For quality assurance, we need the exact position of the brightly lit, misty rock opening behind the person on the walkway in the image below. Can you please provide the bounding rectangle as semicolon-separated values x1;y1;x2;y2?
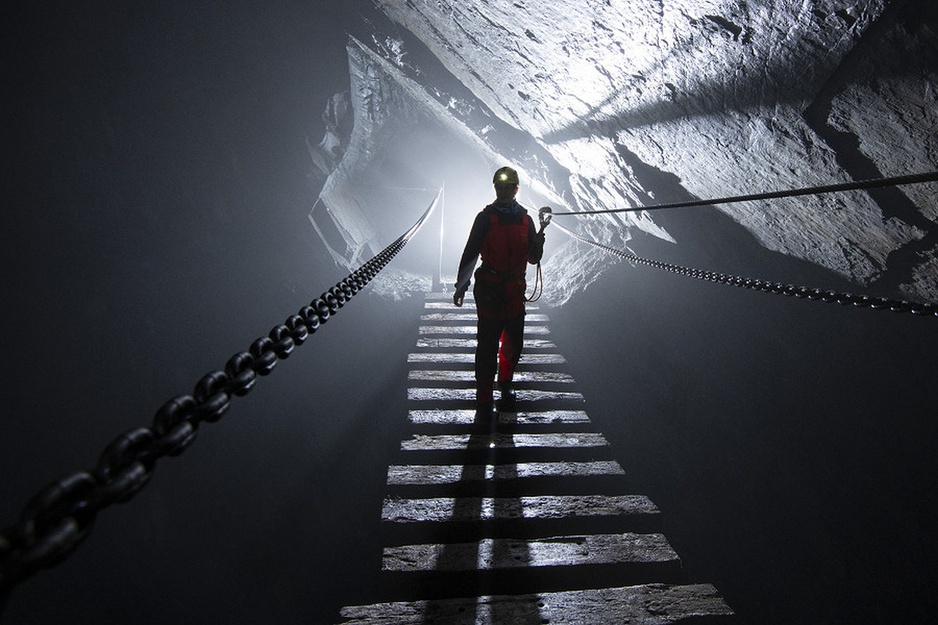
309;35;565;290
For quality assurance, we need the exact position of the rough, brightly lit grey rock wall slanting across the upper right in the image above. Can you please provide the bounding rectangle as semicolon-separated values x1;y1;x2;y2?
362;0;938;303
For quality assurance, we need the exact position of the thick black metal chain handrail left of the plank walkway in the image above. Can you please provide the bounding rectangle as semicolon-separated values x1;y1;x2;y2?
0;193;440;596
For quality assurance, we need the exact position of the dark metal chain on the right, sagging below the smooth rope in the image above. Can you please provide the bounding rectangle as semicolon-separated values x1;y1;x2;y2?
555;222;938;317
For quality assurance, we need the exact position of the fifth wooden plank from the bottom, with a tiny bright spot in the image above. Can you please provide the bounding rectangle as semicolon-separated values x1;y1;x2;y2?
401;432;609;451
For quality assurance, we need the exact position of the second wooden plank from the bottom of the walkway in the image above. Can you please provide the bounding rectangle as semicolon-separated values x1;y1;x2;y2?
381;532;681;572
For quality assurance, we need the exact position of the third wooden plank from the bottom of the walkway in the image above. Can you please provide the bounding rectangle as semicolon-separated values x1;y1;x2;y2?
381;495;659;523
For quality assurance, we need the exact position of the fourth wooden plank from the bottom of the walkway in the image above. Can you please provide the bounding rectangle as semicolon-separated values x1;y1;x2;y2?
387;460;625;486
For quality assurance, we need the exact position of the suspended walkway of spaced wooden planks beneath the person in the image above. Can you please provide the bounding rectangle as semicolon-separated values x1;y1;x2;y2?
341;293;733;625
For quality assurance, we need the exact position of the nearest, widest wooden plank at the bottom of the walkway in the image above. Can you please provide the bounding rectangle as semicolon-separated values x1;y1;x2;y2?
340;584;733;625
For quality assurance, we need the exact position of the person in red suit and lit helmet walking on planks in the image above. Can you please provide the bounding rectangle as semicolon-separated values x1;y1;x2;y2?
453;167;544;410
